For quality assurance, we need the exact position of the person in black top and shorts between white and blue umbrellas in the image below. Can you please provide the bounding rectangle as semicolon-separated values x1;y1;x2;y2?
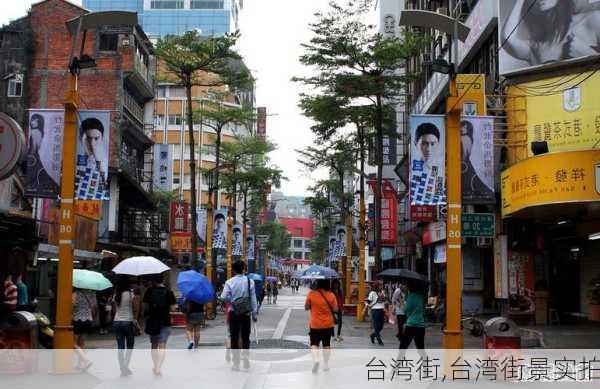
142;274;177;377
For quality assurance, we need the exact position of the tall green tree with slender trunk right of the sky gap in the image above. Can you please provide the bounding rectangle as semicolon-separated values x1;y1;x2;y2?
294;0;427;269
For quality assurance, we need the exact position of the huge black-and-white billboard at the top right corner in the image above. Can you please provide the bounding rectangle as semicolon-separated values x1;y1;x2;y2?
498;0;600;74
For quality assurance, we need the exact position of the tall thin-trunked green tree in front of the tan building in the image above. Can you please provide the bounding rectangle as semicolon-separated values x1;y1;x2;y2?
155;30;252;266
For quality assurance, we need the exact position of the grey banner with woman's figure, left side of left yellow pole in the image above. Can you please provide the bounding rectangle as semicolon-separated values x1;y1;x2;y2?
25;109;65;199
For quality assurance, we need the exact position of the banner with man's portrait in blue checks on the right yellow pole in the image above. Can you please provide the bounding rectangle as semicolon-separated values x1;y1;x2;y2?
410;115;446;205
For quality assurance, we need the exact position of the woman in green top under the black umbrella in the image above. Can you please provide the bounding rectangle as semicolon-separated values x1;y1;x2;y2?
399;284;427;358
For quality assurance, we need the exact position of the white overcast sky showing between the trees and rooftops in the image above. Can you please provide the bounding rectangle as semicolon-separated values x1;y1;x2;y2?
0;0;376;196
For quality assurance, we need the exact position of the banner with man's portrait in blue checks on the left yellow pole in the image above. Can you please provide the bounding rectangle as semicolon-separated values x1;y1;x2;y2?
75;110;110;200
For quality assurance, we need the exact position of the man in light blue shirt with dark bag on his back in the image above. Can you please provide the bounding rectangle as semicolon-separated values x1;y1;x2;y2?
221;261;257;371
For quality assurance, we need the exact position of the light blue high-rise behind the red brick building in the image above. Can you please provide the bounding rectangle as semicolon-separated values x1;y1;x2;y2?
83;0;244;39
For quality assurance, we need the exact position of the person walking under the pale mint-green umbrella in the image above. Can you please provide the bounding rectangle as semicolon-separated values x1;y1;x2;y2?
72;289;98;371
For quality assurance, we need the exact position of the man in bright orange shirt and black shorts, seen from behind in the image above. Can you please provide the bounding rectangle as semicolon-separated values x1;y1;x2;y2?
304;280;338;374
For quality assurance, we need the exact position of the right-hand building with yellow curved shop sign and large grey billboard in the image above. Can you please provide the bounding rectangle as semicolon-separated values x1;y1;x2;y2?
401;0;600;324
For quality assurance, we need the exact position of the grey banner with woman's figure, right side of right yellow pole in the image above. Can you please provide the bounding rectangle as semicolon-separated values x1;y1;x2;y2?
460;116;496;204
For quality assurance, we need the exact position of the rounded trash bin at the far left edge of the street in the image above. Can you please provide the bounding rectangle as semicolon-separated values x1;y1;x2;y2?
0;311;38;374
